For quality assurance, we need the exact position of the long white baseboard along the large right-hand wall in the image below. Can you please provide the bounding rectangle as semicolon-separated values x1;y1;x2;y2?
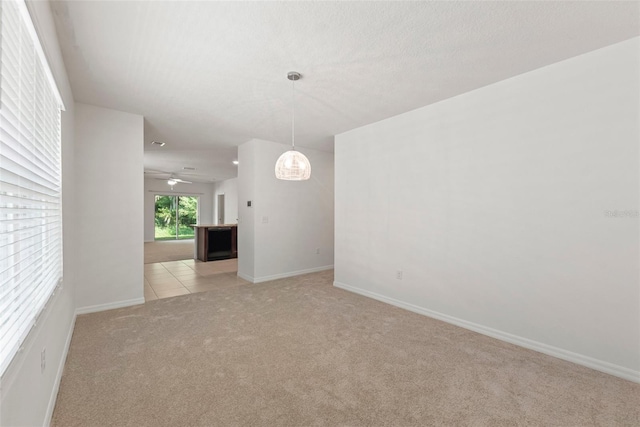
333;281;640;383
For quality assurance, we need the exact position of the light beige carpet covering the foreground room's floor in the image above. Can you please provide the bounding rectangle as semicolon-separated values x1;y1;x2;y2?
53;272;640;426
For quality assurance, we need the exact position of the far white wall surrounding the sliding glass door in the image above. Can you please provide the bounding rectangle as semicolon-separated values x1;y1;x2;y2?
144;178;215;242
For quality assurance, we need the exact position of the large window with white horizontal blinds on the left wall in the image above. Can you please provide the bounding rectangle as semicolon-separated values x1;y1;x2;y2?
0;0;62;374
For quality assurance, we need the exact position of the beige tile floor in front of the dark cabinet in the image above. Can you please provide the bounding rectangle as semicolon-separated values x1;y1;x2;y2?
144;258;250;301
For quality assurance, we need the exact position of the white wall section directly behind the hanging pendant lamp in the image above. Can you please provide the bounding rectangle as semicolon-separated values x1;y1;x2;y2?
238;140;334;283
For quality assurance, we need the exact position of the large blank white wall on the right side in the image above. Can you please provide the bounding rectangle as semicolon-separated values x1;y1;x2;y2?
335;38;640;381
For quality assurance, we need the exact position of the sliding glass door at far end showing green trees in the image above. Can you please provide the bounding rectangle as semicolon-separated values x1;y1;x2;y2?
154;194;198;240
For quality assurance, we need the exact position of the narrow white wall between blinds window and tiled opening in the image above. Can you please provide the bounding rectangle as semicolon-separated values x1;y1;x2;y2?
74;103;144;312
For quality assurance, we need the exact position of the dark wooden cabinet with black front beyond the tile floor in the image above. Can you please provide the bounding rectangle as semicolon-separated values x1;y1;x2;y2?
193;224;238;262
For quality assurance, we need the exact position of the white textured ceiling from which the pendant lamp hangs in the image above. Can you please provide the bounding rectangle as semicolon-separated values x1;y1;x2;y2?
52;1;640;181
